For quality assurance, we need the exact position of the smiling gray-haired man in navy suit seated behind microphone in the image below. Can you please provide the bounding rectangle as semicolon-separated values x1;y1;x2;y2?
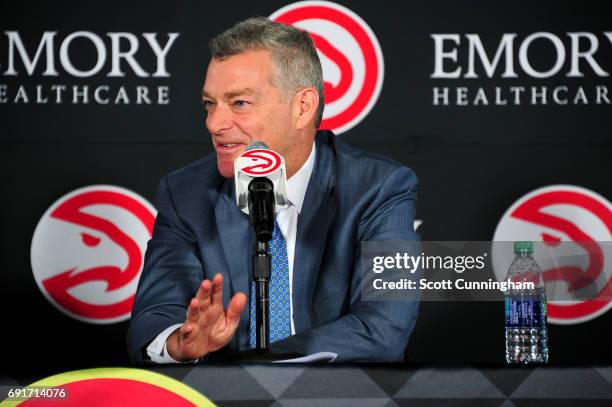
128;18;418;363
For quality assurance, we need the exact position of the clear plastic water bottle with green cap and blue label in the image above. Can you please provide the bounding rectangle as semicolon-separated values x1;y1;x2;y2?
505;242;548;364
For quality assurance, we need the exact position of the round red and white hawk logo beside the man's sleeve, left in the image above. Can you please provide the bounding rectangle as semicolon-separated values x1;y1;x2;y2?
31;185;157;324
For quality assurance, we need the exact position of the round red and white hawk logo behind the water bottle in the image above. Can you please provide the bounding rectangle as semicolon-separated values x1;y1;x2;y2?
493;185;612;324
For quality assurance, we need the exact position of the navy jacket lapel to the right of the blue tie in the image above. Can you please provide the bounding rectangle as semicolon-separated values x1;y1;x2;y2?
292;132;336;333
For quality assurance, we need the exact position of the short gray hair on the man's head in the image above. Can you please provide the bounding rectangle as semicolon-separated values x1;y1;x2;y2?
209;17;324;128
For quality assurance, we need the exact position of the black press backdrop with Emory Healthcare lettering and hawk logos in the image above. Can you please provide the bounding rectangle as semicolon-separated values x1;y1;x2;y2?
0;0;612;372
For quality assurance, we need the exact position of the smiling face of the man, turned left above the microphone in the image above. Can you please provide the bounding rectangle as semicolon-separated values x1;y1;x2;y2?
202;51;295;178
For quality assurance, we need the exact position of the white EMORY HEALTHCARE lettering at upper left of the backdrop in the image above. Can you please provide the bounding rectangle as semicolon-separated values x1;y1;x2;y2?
0;31;180;106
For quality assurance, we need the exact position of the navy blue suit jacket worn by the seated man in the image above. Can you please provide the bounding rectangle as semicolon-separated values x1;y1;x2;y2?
128;131;419;363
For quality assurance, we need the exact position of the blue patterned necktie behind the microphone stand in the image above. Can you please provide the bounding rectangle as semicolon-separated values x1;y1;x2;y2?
250;222;291;348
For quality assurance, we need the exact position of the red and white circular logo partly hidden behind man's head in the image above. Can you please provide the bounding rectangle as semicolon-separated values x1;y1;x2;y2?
270;1;384;134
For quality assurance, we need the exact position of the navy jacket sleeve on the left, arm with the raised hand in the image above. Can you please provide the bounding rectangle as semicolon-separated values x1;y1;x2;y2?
127;179;203;364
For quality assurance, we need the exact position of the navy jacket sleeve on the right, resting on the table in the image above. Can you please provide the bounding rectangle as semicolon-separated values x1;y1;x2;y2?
271;167;420;362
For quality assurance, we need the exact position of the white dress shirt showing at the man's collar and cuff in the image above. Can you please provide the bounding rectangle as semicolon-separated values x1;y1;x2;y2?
147;143;316;363
